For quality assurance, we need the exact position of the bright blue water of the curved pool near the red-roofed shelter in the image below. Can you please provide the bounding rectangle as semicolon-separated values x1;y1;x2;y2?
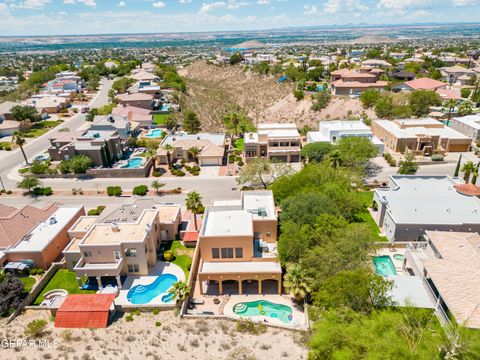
127;274;178;304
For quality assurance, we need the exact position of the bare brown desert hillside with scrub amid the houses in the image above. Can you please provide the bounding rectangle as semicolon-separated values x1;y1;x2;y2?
180;61;374;131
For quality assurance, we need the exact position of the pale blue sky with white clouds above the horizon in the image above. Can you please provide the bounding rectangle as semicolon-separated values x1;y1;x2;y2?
0;0;480;35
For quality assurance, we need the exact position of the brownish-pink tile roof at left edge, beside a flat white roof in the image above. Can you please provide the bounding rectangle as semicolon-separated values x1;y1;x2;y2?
0;203;59;249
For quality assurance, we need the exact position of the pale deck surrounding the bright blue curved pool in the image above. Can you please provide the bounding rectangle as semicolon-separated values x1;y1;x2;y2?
115;261;185;307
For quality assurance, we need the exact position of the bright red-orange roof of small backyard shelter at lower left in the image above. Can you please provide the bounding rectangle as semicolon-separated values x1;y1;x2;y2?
55;294;115;329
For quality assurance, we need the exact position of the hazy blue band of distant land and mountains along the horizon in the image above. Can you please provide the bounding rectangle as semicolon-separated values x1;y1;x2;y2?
0;23;480;52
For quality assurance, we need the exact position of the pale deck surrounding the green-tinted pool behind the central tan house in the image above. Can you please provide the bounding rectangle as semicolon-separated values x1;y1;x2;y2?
223;295;306;329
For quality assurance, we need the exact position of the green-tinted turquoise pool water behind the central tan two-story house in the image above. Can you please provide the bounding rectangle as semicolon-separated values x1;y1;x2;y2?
233;300;293;324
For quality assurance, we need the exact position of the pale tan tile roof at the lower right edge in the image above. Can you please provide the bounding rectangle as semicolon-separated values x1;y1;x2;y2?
422;231;480;328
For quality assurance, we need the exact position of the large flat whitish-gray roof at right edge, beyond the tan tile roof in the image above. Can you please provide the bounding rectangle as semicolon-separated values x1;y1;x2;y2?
375;175;480;225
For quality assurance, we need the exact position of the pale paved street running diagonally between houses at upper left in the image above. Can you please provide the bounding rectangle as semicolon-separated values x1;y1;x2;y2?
0;80;113;188
